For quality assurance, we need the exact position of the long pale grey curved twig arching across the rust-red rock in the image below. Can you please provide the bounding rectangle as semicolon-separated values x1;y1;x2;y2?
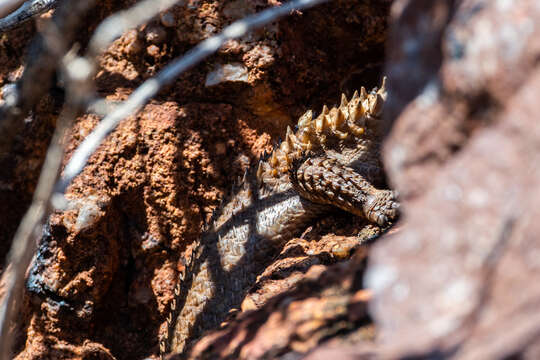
59;0;328;194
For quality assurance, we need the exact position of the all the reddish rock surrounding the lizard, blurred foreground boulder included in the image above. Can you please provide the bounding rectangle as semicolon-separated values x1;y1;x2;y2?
0;0;540;360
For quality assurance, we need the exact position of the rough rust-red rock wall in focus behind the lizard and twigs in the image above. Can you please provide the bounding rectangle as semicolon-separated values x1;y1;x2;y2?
0;0;390;359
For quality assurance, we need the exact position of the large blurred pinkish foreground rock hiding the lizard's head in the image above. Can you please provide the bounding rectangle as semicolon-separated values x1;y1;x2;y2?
366;0;540;359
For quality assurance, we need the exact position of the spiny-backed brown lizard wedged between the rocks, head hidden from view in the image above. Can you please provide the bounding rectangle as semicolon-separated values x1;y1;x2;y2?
159;78;399;358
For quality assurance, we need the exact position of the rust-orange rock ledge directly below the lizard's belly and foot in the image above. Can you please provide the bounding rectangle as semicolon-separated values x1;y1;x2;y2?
177;236;374;359
